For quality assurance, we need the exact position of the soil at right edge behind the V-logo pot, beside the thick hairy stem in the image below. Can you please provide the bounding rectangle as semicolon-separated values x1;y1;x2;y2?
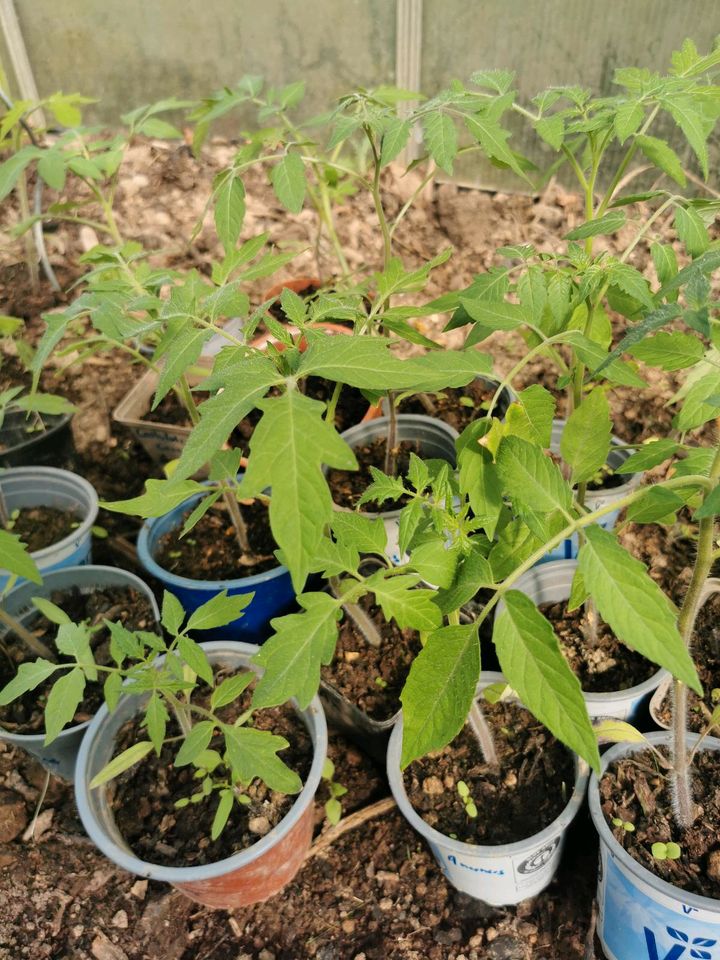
659;593;720;736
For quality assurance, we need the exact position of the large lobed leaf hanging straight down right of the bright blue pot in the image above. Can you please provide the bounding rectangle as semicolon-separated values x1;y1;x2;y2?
241;388;357;590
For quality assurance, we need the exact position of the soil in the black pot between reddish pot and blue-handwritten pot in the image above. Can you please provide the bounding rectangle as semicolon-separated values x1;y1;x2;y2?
322;597;422;721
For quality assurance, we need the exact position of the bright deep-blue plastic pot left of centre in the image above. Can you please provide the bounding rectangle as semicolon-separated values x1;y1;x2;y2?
137;494;295;643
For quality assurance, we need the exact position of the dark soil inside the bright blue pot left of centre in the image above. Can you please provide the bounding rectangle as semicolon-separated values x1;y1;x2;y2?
155;500;278;580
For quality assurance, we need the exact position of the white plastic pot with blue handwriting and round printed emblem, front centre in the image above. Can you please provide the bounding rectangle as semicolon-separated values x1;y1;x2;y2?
387;672;588;907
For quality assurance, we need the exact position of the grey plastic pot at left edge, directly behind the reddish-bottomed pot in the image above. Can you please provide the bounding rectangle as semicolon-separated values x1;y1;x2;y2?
0;565;160;780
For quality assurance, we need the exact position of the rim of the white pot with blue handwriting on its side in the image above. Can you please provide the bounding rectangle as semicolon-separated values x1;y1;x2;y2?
387;670;588;859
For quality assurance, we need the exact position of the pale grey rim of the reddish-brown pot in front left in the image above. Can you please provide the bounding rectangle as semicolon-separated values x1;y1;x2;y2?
75;640;327;885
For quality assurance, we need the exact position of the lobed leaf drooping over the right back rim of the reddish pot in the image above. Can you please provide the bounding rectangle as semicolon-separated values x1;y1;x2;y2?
253;593;340;710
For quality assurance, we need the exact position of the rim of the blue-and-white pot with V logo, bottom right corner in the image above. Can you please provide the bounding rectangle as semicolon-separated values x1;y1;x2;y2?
588;730;720;913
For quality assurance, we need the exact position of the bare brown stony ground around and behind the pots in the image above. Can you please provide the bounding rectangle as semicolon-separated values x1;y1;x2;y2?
0;131;716;960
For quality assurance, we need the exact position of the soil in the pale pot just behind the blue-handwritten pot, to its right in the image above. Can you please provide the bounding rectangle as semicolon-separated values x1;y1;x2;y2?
538;600;658;693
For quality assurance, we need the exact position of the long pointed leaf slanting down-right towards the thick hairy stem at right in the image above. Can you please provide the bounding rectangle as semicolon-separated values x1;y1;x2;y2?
578;526;702;693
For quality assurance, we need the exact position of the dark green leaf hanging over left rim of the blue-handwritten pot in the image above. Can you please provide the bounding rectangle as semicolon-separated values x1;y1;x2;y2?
400;624;480;769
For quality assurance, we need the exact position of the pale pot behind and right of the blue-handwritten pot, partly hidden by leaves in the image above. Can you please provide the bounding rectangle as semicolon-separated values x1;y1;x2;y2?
504;560;668;722
